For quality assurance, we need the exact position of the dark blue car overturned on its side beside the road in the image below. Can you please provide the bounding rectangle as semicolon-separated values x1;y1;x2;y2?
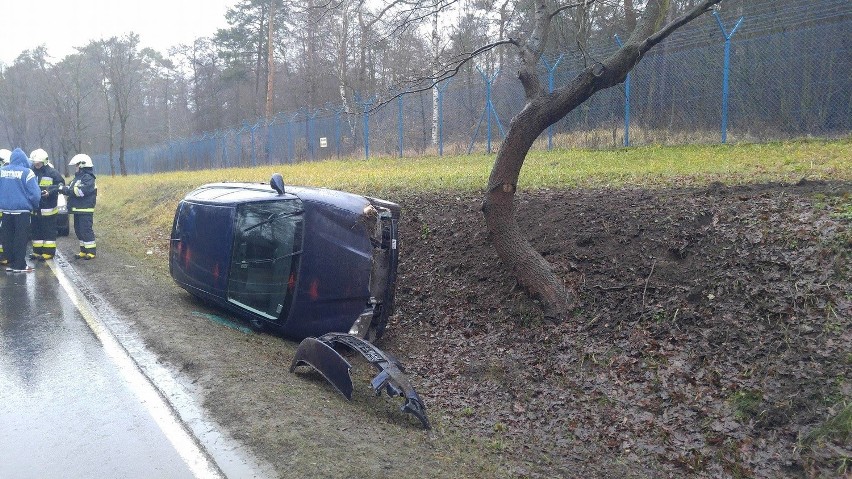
169;174;400;340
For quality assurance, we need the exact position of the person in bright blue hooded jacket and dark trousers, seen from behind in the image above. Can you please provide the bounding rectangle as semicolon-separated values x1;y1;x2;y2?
0;148;41;273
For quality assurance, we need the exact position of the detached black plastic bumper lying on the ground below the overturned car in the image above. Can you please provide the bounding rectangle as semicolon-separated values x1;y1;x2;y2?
290;333;429;429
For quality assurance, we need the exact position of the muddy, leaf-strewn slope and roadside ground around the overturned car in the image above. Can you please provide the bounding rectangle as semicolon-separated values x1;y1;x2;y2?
58;182;852;478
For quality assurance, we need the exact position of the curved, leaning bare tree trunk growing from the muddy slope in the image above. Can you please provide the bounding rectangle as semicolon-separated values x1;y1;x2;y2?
482;0;721;321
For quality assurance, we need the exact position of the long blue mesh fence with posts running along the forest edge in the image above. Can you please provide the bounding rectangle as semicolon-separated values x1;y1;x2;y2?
95;0;852;173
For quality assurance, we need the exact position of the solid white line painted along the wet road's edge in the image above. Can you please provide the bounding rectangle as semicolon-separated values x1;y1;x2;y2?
46;261;225;479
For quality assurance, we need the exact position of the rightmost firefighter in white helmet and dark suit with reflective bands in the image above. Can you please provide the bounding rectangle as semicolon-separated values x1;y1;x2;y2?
59;153;98;259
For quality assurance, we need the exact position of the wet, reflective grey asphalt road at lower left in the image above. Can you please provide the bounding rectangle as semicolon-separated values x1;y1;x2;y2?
0;263;223;479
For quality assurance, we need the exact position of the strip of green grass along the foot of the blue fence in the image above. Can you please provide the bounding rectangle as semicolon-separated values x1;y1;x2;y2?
95;138;852;270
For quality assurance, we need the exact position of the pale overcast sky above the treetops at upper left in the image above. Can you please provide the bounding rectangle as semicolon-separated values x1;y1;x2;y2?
0;0;238;65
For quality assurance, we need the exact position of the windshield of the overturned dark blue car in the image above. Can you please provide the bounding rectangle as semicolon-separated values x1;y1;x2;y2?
228;199;303;319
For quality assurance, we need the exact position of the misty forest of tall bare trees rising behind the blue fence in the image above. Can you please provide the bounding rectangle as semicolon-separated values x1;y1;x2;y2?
0;0;850;176
